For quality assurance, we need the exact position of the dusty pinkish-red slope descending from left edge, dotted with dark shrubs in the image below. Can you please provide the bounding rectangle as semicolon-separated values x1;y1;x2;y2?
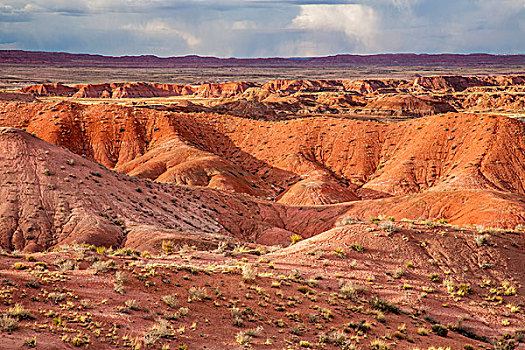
0;128;350;251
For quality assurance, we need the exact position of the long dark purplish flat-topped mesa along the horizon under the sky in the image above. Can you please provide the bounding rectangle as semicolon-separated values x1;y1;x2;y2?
0;50;525;67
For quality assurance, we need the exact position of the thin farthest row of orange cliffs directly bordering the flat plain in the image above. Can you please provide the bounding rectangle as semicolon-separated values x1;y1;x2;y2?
20;76;525;101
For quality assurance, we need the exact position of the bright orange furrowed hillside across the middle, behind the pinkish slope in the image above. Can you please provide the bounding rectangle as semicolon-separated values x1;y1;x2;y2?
0;103;525;227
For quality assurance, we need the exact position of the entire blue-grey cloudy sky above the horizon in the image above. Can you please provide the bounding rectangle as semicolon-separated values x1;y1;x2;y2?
0;0;525;57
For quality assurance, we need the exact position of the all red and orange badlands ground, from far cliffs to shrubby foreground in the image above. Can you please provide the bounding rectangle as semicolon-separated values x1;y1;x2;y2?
0;77;525;349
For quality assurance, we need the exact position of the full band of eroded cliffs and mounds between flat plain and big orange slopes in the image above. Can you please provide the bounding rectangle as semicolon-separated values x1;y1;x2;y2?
21;76;525;120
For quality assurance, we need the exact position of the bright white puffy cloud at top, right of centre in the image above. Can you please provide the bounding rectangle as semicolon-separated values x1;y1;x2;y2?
291;4;377;47
